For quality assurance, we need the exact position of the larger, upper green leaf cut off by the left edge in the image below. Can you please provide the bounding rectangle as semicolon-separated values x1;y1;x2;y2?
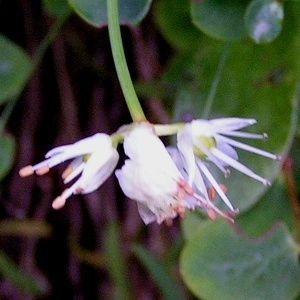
0;34;31;105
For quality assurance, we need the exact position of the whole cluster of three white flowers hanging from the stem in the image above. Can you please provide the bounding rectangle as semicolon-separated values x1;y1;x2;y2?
20;118;279;224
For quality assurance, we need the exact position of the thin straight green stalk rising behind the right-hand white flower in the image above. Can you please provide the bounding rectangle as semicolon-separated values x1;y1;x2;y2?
202;42;231;119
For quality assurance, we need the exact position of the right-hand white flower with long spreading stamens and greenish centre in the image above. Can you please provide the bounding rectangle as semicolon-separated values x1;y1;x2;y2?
177;118;279;210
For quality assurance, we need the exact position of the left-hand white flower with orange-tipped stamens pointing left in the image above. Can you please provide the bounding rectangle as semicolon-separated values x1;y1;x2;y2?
19;133;119;209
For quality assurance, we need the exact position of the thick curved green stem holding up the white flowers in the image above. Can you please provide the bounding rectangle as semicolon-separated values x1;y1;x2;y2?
107;0;147;122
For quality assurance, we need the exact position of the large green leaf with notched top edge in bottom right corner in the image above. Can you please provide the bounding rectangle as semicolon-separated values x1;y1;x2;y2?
180;220;300;300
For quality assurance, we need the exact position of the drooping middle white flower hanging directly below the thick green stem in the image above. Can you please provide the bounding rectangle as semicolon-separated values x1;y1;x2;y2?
116;125;230;224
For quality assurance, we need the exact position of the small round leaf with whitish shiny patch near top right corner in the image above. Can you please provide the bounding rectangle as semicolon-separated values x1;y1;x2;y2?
245;0;283;43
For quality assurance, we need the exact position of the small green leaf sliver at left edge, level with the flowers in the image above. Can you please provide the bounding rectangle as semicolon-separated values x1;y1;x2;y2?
0;135;16;180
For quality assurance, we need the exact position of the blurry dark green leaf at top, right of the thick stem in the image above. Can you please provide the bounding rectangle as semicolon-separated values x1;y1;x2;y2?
154;0;202;51
